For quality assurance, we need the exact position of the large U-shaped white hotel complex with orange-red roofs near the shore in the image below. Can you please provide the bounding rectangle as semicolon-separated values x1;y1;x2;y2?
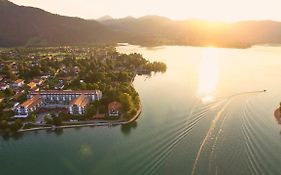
16;90;102;117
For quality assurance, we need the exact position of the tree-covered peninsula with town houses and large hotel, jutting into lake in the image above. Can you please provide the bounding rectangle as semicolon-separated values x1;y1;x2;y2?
0;45;167;133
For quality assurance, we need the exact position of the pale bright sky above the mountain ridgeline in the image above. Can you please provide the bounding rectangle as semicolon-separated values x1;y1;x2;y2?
11;0;281;22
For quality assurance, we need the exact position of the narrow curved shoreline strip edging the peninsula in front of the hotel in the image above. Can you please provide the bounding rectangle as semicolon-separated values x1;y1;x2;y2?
17;104;142;133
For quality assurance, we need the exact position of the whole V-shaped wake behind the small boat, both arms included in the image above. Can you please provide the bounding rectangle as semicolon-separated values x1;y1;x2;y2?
120;91;264;175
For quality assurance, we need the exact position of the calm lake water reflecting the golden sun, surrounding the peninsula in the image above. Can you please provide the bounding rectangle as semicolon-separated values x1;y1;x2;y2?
0;45;281;175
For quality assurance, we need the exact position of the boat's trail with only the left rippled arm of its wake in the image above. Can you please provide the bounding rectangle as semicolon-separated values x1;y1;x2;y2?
127;91;263;175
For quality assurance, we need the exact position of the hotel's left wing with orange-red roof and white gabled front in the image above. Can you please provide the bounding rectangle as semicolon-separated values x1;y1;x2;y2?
16;95;43;117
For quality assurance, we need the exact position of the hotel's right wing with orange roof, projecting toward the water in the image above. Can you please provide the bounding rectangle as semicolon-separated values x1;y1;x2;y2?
68;94;90;115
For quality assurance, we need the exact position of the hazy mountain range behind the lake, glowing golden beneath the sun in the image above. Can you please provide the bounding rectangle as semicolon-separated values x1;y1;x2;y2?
0;0;281;47
